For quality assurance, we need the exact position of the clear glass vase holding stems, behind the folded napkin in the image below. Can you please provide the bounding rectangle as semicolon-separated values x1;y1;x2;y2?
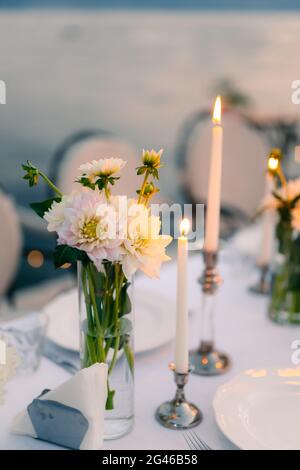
78;262;134;439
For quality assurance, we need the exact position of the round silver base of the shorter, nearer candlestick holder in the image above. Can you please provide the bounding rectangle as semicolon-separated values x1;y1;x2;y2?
155;400;203;430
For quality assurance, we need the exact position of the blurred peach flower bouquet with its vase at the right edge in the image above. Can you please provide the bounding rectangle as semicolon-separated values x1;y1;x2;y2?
263;149;300;323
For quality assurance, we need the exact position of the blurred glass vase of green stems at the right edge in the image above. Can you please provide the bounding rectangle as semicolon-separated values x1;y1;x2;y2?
268;236;300;324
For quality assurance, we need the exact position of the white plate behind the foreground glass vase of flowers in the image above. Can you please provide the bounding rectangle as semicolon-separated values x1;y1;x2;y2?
44;289;175;353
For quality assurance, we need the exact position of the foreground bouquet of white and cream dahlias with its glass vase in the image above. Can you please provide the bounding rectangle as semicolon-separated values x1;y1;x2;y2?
23;150;171;438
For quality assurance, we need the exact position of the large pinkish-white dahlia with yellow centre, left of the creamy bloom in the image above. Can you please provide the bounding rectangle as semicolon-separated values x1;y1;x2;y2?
57;188;121;269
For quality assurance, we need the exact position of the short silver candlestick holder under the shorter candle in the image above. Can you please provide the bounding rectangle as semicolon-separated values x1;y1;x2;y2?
155;363;202;430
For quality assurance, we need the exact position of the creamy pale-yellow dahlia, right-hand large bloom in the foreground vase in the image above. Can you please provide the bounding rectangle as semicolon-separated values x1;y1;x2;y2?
122;201;172;279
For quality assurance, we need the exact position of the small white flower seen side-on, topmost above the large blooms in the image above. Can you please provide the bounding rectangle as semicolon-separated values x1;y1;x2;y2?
79;158;126;183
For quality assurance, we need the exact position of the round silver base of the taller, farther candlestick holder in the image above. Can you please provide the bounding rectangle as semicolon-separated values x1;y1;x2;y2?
190;342;230;376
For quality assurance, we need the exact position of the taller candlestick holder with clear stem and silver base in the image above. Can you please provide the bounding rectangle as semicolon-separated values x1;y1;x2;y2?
190;251;230;375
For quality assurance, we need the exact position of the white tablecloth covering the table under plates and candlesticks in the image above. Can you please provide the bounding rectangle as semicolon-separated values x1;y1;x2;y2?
0;254;300;450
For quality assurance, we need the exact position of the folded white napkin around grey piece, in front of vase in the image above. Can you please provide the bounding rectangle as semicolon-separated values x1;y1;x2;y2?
11;363;108;450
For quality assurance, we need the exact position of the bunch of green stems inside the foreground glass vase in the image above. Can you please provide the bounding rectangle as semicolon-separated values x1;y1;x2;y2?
81;262;134;410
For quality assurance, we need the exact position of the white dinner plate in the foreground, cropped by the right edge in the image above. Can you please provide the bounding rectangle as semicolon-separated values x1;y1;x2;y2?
213;368;300;450
